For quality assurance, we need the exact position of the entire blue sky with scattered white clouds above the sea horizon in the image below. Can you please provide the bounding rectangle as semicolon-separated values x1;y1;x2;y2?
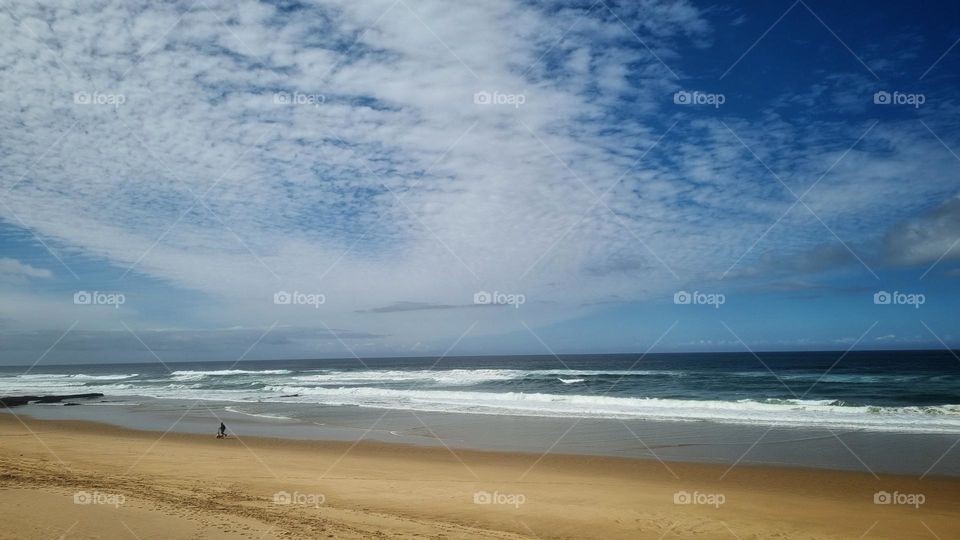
0;0;960;365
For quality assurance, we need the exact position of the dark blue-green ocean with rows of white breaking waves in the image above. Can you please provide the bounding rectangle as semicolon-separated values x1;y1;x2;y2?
0;351;960;434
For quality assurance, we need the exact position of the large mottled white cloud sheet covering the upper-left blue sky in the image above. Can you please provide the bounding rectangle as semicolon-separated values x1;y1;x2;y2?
0;0;950;358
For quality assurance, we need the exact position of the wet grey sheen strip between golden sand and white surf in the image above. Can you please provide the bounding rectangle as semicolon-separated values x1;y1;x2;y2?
7;397;960;477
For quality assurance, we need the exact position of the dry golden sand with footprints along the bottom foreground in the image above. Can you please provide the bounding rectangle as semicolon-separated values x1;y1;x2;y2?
0;415;960;539
